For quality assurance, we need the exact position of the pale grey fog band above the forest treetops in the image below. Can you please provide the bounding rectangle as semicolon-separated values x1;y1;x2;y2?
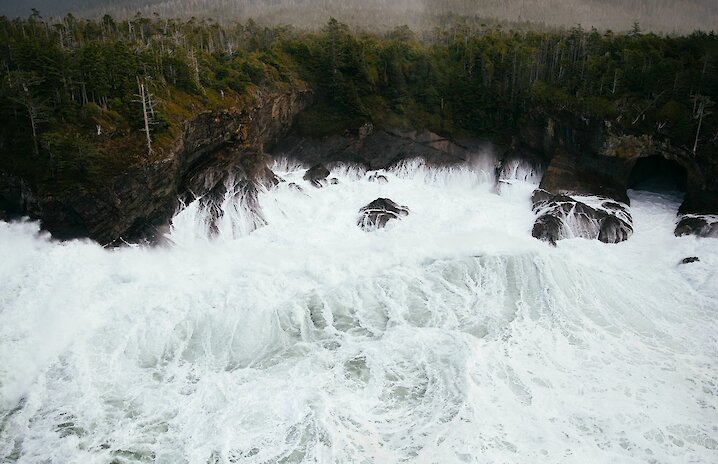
0;0;718;33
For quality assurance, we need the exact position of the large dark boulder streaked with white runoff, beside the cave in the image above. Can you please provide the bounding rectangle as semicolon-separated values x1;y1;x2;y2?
531;190;633;245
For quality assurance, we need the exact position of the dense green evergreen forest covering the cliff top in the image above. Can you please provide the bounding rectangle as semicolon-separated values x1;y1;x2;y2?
0;14;718;191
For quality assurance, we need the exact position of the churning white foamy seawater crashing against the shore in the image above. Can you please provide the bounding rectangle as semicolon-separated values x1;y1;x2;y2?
0;157;718;464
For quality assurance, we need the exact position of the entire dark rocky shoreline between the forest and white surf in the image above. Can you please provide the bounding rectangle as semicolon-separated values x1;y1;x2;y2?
0;95;718;245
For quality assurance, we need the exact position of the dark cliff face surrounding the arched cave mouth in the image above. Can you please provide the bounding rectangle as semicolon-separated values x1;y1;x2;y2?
517;111;718;237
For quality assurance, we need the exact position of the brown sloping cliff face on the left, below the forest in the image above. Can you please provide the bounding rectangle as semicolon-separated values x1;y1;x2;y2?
0;89;311;244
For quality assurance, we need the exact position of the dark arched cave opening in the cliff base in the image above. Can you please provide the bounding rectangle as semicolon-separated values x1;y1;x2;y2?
628;155;688;192
